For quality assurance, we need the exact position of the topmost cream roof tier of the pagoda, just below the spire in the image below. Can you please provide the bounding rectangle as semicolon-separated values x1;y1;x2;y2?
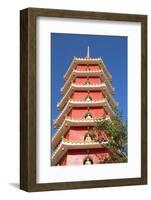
64;57;112;81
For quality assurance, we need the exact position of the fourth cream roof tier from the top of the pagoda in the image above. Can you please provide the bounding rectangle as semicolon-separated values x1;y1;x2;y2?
54;98;115;127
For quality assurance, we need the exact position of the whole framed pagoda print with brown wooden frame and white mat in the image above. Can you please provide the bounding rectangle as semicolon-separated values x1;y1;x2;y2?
20;8;147;191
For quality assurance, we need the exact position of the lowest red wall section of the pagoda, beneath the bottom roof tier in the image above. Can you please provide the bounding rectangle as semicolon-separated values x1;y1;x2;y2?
59;148;110;166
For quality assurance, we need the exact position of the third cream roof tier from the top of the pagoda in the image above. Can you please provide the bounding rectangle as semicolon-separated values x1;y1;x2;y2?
57;83;118;109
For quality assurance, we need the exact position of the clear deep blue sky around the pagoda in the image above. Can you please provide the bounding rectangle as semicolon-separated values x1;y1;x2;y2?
50;33;127;135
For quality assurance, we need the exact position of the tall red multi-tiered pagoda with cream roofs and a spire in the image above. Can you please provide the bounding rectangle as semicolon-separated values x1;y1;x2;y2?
51;47;117;166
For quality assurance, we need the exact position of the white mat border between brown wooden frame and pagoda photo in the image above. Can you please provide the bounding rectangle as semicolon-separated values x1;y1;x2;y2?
36;17;141;183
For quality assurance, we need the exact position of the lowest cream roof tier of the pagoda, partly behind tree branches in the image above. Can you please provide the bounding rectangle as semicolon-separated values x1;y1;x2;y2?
51;139;108;165
